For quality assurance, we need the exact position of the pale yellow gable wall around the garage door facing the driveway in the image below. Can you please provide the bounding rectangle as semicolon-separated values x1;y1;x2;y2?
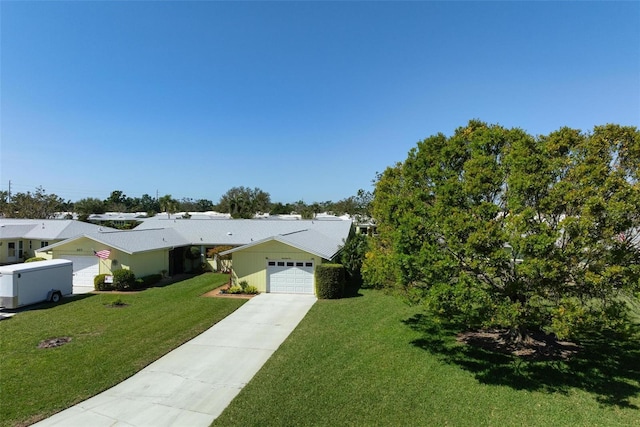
232;241;323;292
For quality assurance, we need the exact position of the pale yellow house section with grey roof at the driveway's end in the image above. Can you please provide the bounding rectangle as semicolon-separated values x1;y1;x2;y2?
137;217;352;294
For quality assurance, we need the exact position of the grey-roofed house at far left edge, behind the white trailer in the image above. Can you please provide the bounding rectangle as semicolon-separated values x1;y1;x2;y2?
0;218;112;264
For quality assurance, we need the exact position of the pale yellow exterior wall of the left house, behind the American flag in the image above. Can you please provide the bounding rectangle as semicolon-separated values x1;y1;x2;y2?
37;237;169;277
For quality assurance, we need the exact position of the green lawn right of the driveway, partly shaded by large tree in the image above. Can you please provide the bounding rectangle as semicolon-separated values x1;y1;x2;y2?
213;290;640;426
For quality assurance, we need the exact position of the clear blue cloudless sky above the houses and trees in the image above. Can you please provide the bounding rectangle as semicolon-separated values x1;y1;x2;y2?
0;1;640;203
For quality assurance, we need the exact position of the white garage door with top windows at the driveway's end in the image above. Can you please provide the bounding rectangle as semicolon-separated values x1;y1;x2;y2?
267;260;314;295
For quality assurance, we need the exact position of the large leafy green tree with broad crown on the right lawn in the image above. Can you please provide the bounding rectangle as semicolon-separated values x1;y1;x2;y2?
363;121;640;339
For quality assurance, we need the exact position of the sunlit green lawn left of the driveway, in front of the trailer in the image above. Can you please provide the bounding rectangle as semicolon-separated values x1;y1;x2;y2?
0;274;244;426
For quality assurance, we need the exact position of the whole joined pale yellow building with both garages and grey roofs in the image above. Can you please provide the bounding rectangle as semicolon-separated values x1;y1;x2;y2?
37;219;352;294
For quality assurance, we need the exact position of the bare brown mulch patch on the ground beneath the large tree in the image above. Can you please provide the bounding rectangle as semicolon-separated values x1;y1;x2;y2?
457;329;580;360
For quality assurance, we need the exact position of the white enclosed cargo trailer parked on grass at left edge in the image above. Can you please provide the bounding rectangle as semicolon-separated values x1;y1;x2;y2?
0;259;73;308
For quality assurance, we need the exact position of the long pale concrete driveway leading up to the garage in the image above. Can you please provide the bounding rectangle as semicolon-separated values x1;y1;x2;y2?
35;294;316;427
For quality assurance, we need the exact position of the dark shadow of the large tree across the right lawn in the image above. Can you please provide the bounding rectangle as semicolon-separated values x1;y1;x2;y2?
404;314;640;409
